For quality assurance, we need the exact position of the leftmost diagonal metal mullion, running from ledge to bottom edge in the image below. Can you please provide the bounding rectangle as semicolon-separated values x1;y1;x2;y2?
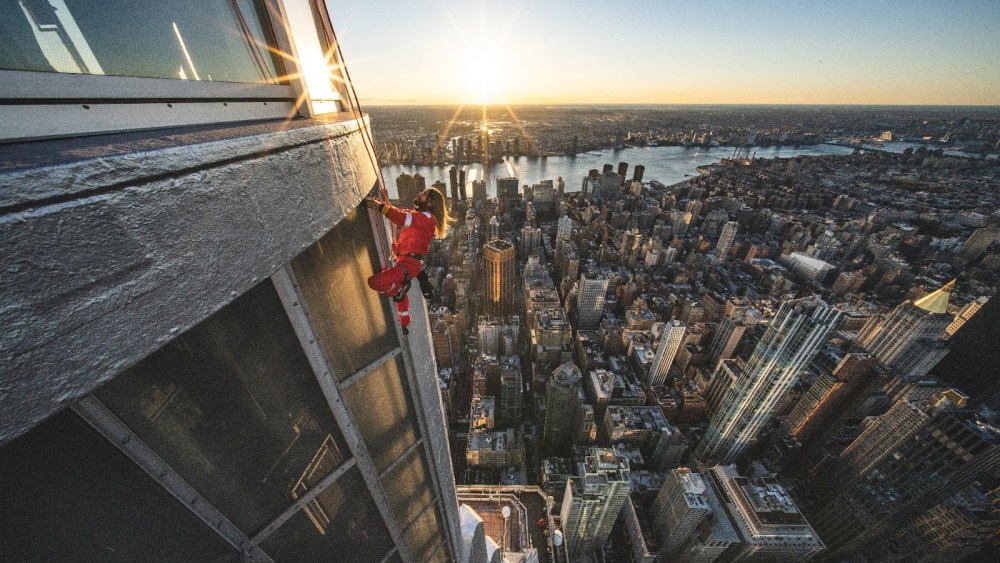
72;395;273;563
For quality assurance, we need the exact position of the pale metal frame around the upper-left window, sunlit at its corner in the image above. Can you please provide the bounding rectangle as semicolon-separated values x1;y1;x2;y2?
0;0;347;143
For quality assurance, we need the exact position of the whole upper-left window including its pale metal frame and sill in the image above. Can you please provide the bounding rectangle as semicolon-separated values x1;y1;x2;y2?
0;0;314;141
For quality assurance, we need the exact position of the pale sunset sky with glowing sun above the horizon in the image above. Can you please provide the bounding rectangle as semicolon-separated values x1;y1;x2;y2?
327;0;1000;105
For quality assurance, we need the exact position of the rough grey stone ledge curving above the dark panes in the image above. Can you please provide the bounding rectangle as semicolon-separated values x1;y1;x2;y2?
0;114;376;443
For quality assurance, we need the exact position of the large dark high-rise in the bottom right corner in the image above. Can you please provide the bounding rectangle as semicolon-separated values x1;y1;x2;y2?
813;390;1000;561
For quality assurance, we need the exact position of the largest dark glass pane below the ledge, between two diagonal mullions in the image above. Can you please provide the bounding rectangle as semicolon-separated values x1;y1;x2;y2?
97;280;349;534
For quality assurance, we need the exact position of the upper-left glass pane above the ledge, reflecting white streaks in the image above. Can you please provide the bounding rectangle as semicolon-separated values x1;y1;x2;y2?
0;0;282;84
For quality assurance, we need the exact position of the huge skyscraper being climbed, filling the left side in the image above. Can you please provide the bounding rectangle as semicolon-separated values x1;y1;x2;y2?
0;2;462;561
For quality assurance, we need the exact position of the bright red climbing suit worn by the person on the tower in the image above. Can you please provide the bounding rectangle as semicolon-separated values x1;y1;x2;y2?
368;204;437;328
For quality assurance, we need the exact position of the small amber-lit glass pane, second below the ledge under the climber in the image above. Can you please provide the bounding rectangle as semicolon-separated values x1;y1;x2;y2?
344;356;418;473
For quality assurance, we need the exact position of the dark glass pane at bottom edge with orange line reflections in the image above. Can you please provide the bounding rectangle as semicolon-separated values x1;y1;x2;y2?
261;469;394;563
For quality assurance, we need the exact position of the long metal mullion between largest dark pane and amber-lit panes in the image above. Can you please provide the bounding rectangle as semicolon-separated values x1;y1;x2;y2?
271;264;413;562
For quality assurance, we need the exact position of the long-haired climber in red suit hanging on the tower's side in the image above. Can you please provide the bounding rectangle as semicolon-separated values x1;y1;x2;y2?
365;188;450;334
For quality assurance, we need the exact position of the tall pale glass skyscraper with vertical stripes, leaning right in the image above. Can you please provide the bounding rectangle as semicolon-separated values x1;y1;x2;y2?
696;296;840;463
